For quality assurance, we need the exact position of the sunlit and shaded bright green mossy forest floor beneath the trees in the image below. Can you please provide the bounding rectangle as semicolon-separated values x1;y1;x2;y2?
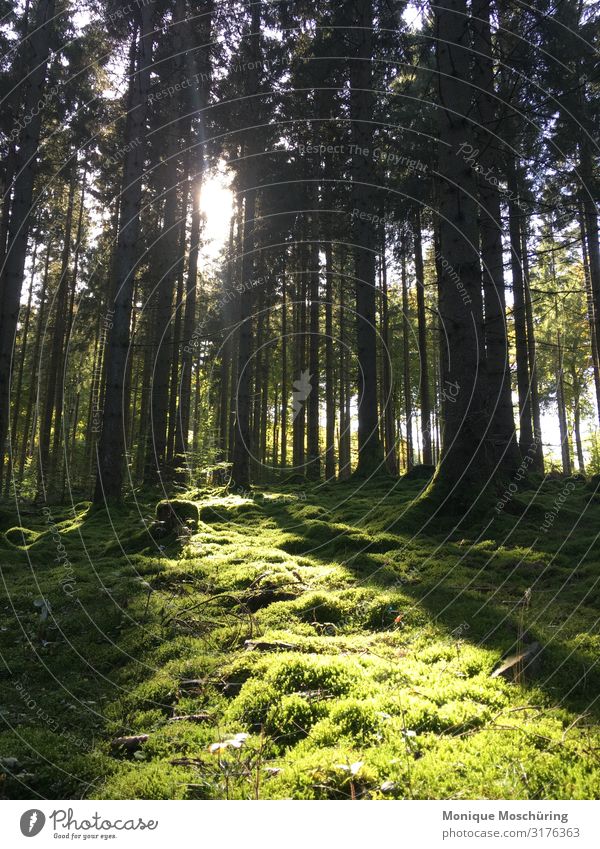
0;478;600;799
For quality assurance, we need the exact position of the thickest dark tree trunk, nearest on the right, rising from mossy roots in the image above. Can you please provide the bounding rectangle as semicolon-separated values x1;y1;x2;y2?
434;0;495;489
